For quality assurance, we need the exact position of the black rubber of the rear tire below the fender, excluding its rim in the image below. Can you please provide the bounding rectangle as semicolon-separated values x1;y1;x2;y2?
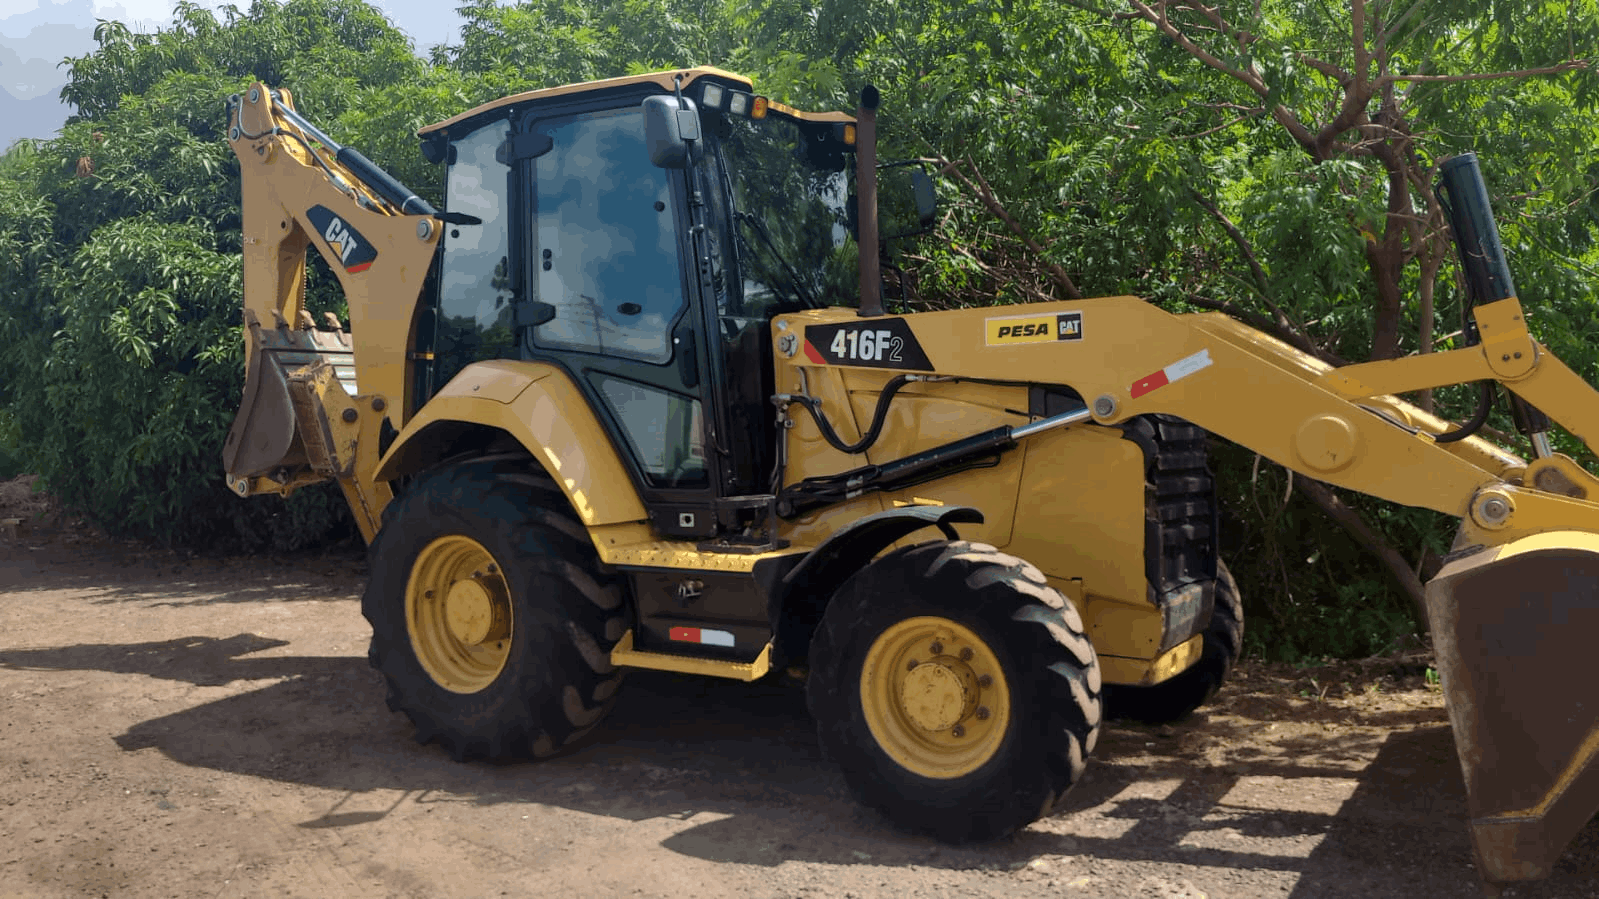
361;457;627;761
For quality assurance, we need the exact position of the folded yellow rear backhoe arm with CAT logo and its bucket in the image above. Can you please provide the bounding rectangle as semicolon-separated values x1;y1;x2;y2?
222;83;440;541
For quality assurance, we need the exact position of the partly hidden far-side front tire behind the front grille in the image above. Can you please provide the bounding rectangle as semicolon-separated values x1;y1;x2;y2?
1105;561;1244;725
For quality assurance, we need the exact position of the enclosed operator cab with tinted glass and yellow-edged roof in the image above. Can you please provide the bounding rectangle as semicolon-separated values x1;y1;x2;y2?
416;69;857;542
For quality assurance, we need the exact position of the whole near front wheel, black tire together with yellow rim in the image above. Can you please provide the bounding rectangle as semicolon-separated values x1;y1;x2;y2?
806;541;1100;841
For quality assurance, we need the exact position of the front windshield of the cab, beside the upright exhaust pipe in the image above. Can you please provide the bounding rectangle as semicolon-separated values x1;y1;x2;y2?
708;114;859;320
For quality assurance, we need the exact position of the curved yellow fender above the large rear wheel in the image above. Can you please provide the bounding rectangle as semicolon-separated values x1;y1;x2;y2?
376;360;646;528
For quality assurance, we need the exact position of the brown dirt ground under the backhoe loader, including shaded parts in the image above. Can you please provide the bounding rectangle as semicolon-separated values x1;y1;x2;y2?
0;481;1599;899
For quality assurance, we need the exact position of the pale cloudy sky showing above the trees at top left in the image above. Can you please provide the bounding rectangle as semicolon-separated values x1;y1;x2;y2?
0;0;461;150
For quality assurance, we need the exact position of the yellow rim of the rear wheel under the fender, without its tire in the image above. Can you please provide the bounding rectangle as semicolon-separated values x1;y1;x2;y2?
405;534;512;693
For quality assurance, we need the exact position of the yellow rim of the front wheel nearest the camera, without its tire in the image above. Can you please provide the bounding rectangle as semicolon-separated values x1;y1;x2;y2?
860;616;1011;779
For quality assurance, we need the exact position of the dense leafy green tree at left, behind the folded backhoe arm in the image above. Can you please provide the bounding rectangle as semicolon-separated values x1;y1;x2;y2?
0;0;461;547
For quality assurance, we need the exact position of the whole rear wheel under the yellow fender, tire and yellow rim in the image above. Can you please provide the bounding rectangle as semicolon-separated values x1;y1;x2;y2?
361;459;625;761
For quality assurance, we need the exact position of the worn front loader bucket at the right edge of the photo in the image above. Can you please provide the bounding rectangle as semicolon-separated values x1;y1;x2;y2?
1426;531;1599;883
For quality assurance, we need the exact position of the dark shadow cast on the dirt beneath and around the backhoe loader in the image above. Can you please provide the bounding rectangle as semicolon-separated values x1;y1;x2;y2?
9;633;1599;899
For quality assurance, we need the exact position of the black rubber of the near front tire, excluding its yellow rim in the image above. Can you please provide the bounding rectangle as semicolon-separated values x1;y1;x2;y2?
806;541;1100;843
